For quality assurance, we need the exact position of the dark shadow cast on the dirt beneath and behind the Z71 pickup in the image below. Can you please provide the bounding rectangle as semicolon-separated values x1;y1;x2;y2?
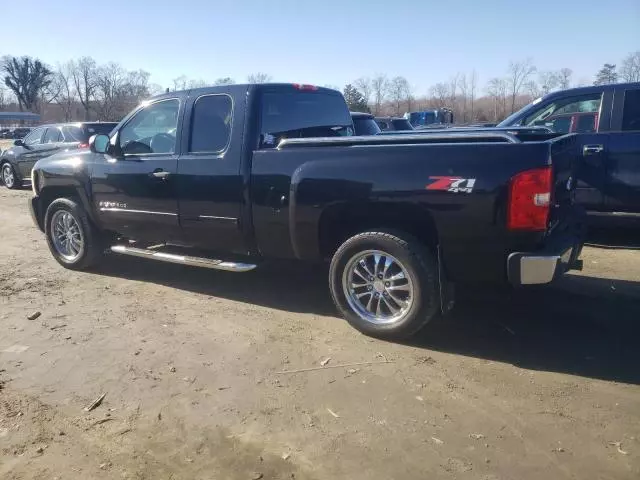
96;256;640;384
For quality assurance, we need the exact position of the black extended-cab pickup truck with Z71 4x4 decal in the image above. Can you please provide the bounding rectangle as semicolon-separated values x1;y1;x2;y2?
30;84;582;338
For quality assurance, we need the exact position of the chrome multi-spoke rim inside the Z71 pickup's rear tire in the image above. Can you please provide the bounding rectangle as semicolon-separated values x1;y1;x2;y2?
342;250;414;325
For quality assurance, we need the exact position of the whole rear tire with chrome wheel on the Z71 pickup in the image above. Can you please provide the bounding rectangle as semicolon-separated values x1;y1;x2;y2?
329;231;440;339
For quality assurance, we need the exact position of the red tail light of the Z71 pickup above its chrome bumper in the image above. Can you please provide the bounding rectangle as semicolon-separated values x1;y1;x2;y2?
507;167;553;231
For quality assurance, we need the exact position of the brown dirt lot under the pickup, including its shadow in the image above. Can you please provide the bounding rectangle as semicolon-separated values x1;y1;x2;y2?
0;188;640;480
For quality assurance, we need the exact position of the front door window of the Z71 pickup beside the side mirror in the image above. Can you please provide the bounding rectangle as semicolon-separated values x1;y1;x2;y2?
118;98;180;155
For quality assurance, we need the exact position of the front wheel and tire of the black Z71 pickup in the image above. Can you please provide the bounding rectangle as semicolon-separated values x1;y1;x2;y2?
44;198;104;270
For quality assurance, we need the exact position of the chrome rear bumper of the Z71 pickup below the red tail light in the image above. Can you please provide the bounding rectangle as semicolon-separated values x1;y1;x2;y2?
507;221;584;285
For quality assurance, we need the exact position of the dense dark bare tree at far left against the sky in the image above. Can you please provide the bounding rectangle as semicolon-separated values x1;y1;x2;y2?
1;57;52;110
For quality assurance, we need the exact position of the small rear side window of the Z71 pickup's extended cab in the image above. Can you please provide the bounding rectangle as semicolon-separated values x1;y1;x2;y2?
189;95;233;152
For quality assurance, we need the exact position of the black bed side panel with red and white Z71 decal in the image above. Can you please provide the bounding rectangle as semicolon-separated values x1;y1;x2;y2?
252;143;550;280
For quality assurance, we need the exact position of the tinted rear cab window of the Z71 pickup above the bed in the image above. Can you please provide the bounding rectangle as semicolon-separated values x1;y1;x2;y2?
260;85;352;148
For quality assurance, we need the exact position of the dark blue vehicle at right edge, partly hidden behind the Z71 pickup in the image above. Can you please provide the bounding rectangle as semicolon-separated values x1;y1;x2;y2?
498;83;640;220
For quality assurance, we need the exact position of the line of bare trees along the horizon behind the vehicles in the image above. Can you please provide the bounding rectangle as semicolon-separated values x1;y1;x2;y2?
0;51;640;123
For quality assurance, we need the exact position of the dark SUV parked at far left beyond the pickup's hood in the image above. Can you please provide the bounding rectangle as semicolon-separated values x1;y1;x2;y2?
0;122;117;188
